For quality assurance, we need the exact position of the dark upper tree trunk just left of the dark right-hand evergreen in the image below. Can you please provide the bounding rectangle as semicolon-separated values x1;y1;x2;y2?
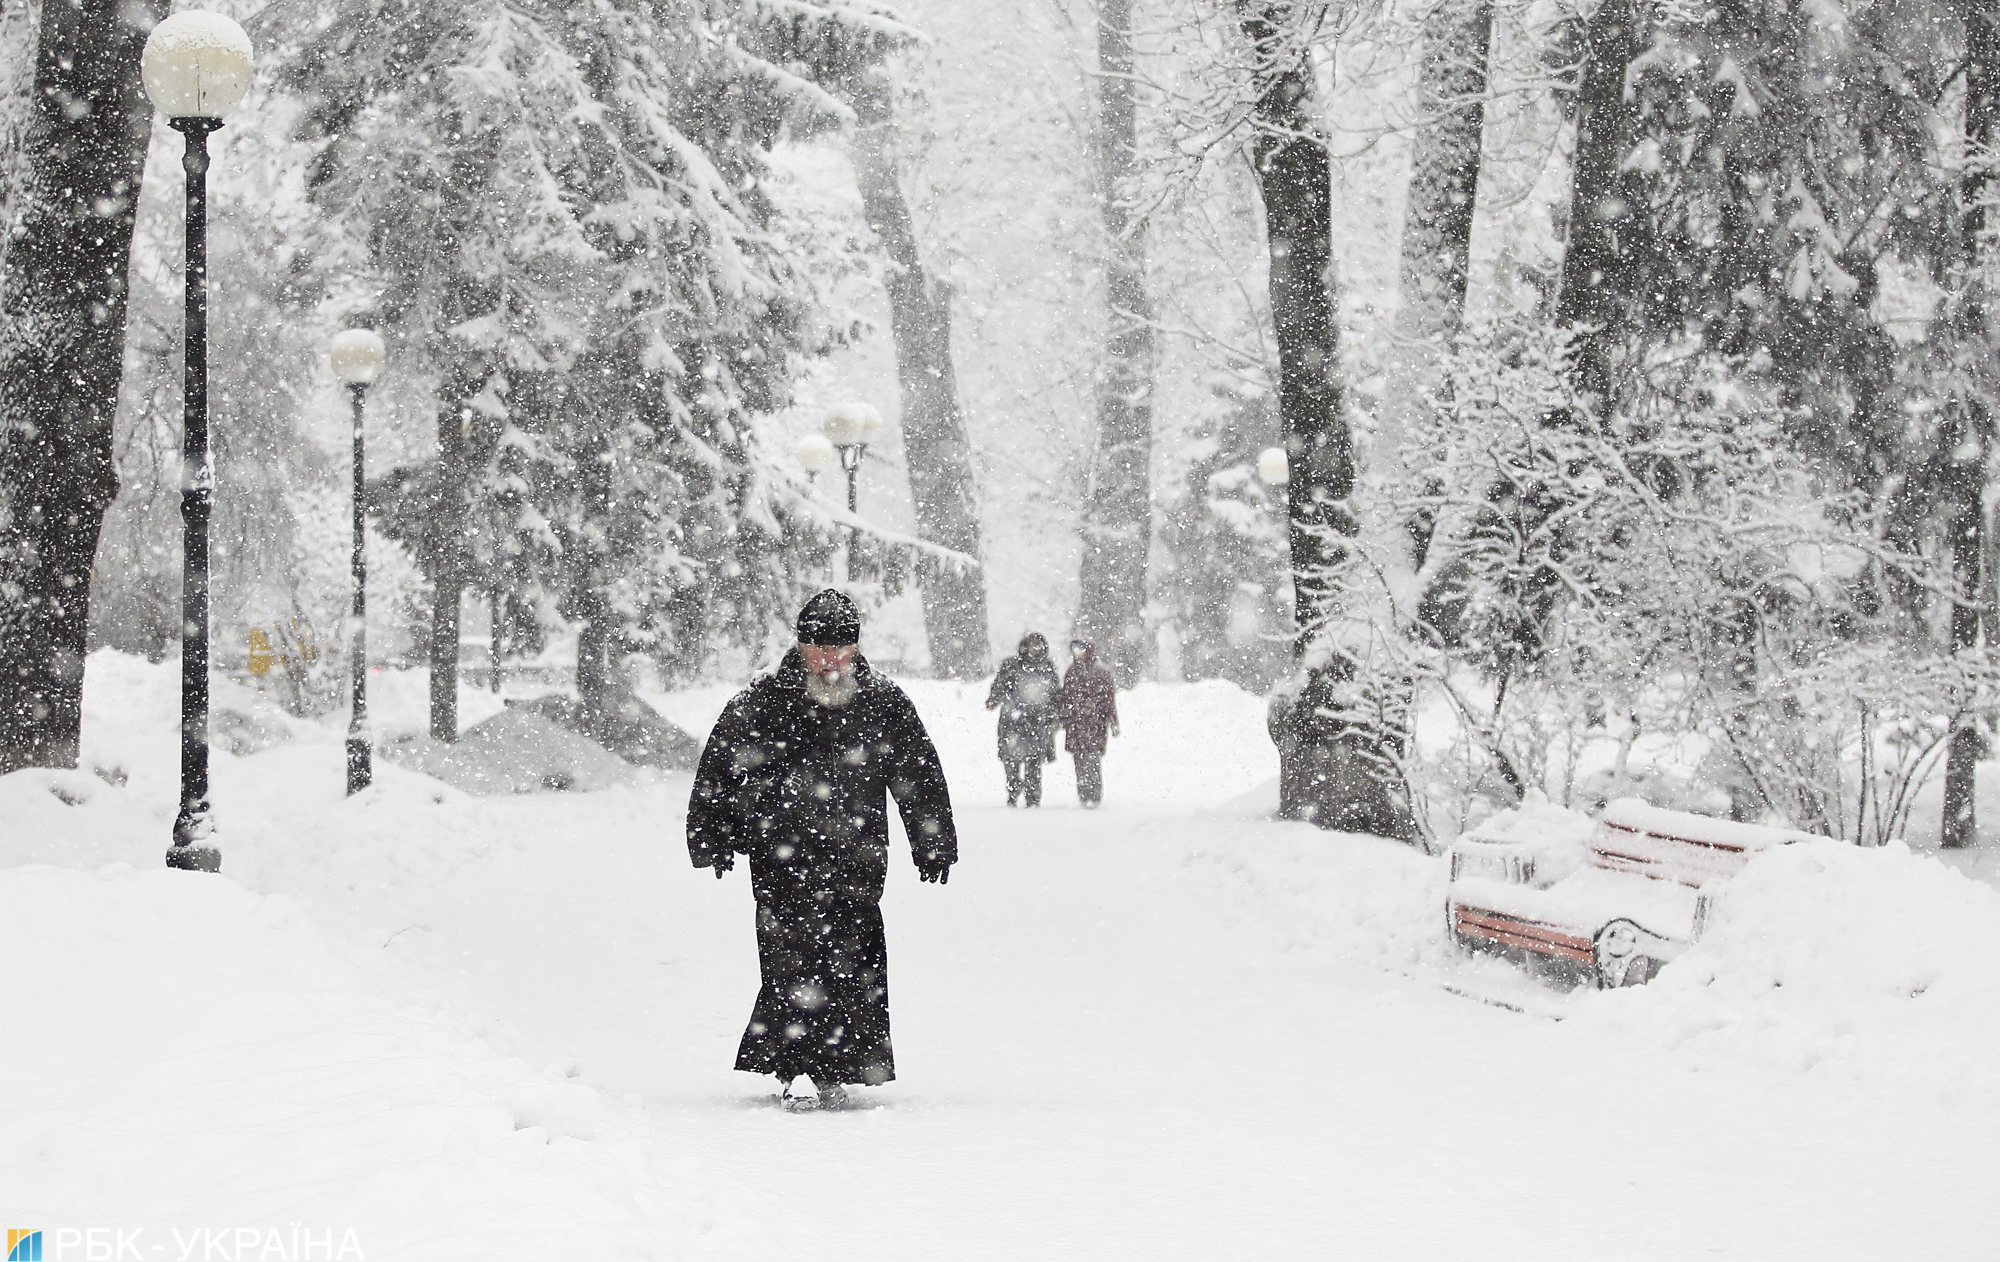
1556;0;1646;402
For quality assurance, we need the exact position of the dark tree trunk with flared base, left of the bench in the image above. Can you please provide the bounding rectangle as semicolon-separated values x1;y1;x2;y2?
1238;9;1416;838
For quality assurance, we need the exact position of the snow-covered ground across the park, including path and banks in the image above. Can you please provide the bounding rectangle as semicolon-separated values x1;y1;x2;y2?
0;654;2000;1262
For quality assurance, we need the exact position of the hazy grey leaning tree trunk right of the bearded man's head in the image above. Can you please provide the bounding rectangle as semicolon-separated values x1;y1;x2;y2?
852;82;988;680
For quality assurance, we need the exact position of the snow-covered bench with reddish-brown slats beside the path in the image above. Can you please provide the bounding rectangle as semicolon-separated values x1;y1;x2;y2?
1446;798;1806;988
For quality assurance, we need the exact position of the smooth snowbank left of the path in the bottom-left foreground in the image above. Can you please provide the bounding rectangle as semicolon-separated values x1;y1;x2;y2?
0;866;780;1260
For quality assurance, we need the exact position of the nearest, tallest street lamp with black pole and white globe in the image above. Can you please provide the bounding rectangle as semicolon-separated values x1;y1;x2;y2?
140;10;250;872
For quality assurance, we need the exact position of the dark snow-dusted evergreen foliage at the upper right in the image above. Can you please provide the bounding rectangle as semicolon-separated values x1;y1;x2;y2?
1558;0;1964;478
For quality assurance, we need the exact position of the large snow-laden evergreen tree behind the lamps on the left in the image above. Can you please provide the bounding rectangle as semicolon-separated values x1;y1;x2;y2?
260;0;868;738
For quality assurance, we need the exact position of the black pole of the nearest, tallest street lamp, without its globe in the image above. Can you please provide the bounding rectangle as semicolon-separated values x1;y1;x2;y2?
166;116;222;872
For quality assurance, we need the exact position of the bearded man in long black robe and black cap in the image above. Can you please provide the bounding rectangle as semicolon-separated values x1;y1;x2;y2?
688;588;958;1110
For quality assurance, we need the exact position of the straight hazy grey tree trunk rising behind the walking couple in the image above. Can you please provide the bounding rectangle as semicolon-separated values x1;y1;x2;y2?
1076;0;1152;686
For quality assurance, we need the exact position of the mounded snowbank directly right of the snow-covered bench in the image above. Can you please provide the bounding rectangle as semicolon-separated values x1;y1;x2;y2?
1578;840;2000;1102
